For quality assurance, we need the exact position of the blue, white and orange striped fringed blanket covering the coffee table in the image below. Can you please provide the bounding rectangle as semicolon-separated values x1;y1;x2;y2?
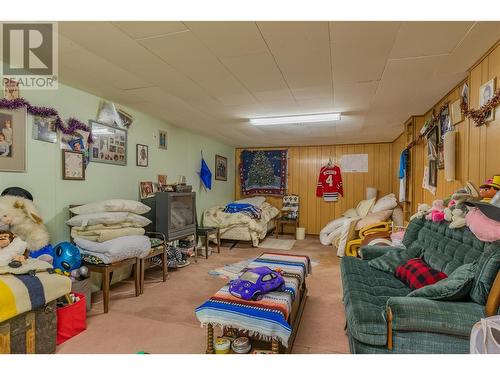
195;253;311;347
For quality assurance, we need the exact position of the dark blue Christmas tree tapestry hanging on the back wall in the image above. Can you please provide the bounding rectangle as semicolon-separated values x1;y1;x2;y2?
240;150;288;195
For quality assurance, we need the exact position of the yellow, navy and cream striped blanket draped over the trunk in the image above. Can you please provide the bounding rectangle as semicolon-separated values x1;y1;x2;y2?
0;272;71;322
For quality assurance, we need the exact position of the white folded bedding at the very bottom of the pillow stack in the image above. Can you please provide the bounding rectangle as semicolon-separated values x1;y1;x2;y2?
75;236;151;263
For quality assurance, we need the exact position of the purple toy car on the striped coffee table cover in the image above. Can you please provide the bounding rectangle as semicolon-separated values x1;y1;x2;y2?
229;267;285;301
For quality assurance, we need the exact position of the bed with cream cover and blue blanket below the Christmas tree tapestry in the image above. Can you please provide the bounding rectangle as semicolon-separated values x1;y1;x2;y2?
203;197;280;246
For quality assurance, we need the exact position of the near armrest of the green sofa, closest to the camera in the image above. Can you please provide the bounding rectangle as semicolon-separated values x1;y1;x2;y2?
386;297;486;337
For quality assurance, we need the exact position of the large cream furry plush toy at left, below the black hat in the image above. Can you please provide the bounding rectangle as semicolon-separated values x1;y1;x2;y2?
0;195;49;250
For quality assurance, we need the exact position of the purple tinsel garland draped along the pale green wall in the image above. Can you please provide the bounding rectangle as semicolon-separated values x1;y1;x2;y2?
0;98;94;143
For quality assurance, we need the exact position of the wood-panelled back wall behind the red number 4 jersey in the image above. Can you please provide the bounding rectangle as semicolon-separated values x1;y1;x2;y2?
235;143;394;234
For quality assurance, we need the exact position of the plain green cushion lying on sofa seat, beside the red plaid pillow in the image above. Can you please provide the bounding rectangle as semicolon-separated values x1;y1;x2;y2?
407;263;477;301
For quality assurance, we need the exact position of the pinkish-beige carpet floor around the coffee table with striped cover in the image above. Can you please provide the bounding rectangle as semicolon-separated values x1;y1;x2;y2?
57;236;349;354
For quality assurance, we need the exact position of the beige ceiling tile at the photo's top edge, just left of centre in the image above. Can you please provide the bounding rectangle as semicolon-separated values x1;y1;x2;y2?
185;21;267;58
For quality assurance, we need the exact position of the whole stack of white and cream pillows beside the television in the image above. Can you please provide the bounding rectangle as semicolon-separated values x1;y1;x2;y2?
66;199;151;263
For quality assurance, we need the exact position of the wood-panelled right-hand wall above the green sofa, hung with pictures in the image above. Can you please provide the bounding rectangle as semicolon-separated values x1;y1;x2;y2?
393;43;500;210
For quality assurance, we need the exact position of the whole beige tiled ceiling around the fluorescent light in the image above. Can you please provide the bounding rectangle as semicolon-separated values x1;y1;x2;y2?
55;21;500;147
